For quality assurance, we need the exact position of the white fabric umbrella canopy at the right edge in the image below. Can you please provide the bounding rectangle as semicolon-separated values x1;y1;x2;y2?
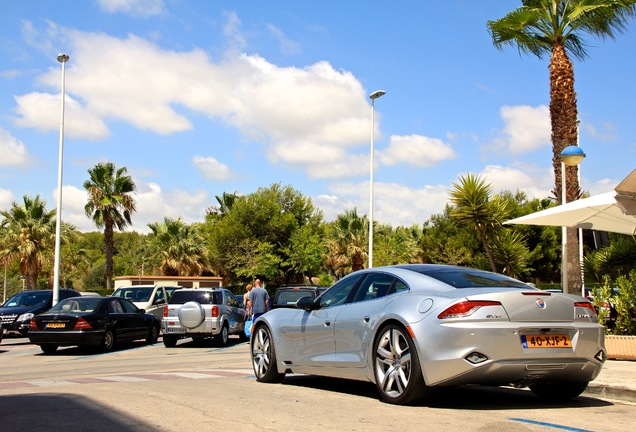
505;170;636;235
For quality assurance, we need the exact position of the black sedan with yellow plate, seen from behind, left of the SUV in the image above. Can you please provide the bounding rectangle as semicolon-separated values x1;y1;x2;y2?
28;297;161;354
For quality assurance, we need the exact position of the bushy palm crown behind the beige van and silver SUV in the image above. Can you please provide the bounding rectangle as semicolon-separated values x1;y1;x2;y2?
148;217;209;276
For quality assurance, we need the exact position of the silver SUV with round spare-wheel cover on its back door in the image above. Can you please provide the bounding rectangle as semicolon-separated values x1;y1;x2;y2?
161;288;247;348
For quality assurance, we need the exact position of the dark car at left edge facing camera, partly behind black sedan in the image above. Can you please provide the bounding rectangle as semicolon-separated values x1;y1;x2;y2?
0;289;80;336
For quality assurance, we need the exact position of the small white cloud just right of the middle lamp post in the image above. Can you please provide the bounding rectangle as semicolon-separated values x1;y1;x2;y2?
379;134;457;168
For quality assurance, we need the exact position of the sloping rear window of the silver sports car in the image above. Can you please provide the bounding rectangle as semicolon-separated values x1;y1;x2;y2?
407;266;537;290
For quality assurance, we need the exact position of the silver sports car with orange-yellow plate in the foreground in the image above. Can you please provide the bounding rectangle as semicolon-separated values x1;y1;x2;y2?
250;264;606;404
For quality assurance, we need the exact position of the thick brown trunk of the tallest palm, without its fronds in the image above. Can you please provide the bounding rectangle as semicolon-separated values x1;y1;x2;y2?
550;44;582;294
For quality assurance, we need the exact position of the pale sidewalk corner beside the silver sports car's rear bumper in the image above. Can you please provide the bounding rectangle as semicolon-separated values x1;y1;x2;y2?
583;360;636;402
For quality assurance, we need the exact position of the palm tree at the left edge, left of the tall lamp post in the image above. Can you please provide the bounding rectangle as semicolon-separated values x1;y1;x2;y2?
0;195;56;290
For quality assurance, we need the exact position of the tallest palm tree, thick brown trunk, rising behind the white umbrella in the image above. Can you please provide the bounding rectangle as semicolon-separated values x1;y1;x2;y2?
488;0;636;293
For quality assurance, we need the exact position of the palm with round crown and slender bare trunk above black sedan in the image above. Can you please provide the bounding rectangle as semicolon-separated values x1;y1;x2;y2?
84;162;137;290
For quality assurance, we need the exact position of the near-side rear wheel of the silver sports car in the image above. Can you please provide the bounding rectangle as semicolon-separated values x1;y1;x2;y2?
373;324;431;405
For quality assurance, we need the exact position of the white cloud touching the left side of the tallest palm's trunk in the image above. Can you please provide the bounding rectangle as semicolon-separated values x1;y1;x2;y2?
486;105;551;155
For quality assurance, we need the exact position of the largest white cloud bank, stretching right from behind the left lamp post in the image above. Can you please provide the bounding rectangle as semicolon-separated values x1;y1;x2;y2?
16;21;369;174
